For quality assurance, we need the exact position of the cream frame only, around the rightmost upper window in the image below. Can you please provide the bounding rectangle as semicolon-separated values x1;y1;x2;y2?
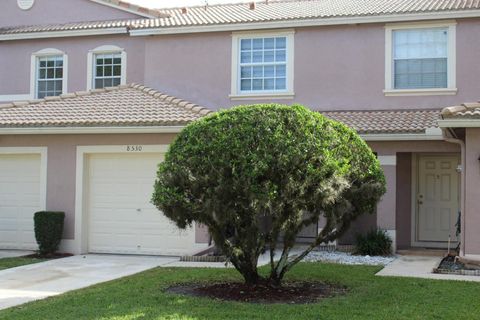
383;20;457;96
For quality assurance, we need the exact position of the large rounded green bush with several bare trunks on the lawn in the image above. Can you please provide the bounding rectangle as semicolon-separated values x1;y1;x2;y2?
152;104;385;284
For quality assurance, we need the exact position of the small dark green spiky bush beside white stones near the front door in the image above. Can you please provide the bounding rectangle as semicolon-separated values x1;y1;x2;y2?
355;229;392;256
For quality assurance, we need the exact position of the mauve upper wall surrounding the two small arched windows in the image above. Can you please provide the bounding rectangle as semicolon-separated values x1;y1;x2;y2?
0;35;145;102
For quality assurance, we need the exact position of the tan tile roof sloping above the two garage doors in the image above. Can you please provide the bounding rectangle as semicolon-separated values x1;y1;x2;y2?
0;84;210;128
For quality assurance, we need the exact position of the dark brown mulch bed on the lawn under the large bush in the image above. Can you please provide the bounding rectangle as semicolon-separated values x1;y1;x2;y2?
166;282;347;304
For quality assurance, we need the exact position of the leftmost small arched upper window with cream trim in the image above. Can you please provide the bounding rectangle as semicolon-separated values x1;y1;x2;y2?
30;49;67;99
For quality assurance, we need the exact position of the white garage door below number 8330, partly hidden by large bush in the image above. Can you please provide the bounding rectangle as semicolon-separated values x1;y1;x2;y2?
86;153;195;255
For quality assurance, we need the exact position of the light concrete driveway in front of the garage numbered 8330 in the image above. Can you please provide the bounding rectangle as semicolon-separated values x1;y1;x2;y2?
0;254;178;309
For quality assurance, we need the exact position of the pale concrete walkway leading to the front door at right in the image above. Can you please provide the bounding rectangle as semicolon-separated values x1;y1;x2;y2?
377;256;480;282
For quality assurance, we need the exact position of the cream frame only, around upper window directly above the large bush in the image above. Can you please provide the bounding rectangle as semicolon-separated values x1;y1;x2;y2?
229;29;295;100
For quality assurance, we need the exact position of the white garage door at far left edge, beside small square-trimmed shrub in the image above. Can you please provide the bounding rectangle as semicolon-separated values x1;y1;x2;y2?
0;154;41;250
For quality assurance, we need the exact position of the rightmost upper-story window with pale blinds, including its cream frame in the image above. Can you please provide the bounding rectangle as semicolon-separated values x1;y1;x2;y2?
385;23;456;95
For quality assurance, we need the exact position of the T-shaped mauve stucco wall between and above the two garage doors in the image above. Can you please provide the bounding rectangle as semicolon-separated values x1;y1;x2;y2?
0;134;174;239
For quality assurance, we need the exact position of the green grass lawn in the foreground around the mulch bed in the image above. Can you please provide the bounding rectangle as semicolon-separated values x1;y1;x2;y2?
0;263;480;320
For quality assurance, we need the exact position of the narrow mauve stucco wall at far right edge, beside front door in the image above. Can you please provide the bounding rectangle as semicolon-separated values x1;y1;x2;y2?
463;128;480;256
